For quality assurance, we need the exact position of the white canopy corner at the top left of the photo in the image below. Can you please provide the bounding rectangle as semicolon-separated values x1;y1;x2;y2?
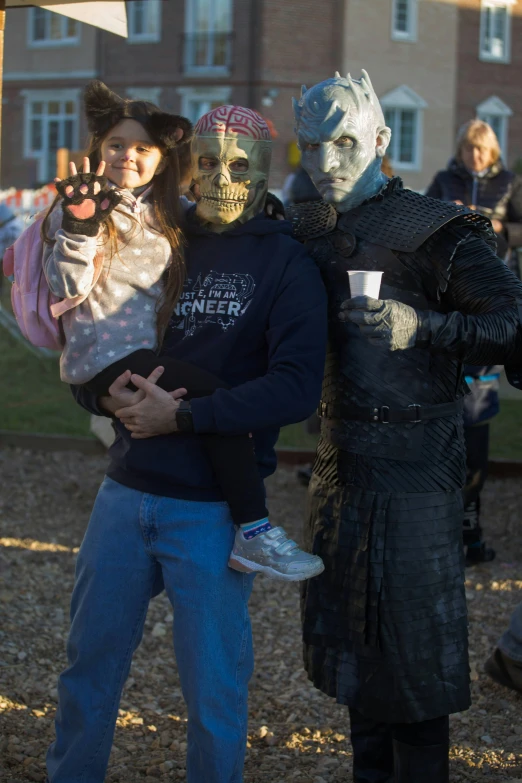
5;0;127;38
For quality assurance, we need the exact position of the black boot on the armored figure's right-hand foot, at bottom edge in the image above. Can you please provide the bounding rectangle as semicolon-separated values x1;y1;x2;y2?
393;740;449;783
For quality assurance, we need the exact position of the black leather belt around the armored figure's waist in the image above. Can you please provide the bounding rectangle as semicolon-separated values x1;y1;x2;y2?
317;398;464;424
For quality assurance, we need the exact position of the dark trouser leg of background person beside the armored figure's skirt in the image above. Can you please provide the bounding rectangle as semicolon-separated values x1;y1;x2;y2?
463;424;489;546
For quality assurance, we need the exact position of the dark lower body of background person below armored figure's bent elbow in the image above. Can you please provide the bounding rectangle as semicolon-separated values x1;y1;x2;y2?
462;364;502;566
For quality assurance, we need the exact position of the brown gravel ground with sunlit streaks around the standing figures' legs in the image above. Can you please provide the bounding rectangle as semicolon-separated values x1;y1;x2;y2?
0;449;522;783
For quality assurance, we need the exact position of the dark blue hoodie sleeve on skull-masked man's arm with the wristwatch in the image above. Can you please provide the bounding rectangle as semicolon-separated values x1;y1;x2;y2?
187;249;327;433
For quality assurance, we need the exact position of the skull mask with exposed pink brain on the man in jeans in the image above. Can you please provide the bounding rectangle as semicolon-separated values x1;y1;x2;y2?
192;106;272;231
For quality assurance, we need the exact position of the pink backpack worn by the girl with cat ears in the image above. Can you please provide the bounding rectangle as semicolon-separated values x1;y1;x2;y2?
4;213;103;351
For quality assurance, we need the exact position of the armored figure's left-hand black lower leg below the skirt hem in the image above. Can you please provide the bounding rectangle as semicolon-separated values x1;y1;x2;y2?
350;709;393;783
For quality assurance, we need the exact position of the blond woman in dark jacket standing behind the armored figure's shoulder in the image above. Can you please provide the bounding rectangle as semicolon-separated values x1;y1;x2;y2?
426;119;522;277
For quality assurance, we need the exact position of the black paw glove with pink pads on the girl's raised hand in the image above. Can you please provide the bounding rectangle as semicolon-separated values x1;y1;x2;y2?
56;172;121;237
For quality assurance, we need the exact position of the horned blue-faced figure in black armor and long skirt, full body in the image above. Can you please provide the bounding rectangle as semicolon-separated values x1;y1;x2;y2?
289;71;522;783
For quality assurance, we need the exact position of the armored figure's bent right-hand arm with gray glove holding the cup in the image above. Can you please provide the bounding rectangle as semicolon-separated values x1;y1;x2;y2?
339;229;522;365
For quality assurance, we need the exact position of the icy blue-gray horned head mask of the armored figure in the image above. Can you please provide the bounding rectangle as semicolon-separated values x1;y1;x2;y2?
294;71;391;212
